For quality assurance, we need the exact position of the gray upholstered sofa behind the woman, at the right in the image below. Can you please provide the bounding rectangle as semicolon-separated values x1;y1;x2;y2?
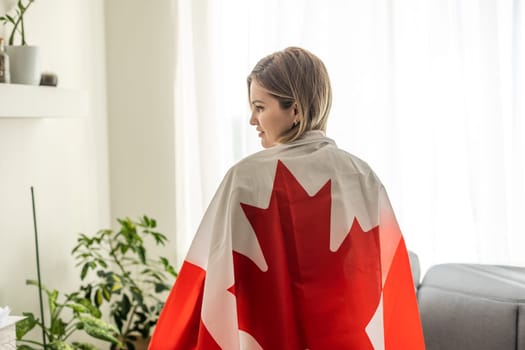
410;253;525;350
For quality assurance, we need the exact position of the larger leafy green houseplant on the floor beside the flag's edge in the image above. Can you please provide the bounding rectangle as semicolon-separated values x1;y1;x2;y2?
72;216;177;350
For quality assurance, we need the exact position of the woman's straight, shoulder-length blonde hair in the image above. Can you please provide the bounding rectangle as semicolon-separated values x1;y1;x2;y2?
247;47;332;143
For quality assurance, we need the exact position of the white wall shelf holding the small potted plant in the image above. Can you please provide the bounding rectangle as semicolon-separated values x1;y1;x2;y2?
0;84;88;118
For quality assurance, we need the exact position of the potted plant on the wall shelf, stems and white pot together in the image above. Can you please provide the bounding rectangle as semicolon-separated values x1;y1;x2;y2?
0;0;40;85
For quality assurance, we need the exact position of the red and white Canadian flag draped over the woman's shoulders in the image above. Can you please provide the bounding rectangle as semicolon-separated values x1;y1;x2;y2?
150;131;424;350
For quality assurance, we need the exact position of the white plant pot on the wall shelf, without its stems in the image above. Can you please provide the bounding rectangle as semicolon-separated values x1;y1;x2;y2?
6;45;40;85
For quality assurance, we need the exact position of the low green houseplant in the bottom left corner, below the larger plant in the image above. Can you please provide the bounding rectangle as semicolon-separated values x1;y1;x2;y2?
16;280;121;350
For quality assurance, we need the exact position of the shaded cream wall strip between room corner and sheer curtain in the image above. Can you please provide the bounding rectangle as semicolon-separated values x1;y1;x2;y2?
105;0;175;262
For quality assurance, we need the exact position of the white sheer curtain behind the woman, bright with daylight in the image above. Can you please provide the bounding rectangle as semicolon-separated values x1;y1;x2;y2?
171;0;525;268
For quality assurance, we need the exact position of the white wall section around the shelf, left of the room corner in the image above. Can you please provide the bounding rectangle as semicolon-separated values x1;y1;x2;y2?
0;0;110;340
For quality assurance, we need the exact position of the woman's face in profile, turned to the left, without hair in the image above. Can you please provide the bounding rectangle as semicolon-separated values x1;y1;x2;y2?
250;80;297;148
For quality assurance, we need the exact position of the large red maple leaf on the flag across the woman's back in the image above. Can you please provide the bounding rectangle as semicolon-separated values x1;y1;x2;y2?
230;161;381;350
